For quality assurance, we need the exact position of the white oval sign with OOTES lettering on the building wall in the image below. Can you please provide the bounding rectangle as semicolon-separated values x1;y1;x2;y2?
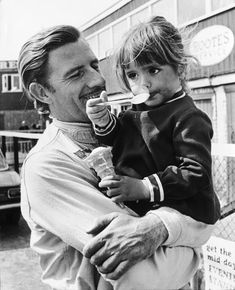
189;25;234;66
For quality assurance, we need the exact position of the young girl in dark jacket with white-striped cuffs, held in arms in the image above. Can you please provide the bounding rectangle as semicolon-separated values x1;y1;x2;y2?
87;17;220;224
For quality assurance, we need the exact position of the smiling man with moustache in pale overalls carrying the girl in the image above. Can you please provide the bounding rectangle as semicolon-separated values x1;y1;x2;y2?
18;26;216;290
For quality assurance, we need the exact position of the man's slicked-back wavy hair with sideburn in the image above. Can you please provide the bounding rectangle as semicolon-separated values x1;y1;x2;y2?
18;25;81;112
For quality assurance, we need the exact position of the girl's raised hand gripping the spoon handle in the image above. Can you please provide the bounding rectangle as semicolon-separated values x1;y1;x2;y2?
86;92;110;128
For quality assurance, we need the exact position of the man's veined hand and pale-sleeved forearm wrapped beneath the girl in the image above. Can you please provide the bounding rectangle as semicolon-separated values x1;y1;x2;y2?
83;207;213;280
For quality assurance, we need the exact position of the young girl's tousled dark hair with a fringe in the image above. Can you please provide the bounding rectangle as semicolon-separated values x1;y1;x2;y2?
115;16;194;90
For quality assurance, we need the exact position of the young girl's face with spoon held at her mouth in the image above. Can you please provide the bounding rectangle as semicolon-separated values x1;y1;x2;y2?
125;62;181;107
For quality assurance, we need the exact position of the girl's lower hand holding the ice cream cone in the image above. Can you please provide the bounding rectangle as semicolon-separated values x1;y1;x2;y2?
99;175;150;202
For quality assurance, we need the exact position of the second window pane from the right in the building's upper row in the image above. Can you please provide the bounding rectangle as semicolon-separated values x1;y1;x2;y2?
178;0;206;24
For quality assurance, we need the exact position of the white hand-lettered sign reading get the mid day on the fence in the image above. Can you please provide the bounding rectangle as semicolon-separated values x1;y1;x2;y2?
203;237;235;290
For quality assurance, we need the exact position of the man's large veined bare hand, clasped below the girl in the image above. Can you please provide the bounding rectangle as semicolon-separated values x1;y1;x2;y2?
83;213;168;280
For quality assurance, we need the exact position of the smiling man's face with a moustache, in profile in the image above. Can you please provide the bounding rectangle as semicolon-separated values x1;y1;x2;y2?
46;38;105;122
